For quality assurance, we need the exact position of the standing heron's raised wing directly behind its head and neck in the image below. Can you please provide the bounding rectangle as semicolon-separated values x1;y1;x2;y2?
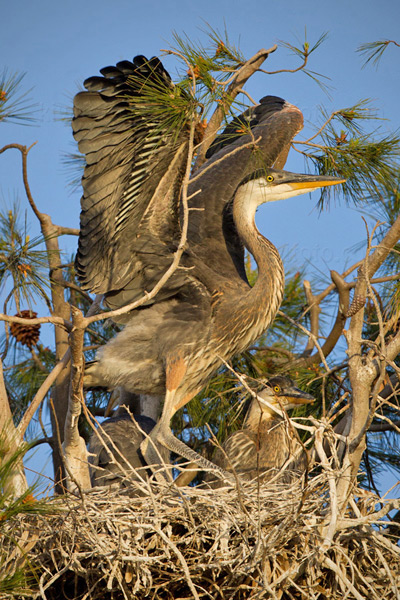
189;96;303;281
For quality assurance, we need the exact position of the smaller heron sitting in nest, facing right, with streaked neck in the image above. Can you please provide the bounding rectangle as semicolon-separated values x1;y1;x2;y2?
206;375;315;487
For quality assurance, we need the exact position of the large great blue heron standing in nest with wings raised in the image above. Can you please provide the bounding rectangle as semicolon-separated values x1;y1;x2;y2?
73;56;342;478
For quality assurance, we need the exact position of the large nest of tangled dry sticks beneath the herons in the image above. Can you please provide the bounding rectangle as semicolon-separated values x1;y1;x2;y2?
1;473;400;600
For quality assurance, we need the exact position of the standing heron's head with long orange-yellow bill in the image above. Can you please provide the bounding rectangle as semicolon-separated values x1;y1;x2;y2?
237;169;346;207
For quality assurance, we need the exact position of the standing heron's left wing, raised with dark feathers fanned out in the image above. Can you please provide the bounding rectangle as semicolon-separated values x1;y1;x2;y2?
72;56;195;298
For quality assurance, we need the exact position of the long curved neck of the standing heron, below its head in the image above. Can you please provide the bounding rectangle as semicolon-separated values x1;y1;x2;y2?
233;186;285;321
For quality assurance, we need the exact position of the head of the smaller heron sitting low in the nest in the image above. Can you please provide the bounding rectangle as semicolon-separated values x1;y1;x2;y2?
257;375;315;412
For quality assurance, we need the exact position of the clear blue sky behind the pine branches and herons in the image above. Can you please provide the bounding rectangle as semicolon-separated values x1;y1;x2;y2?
0;0;400;492
